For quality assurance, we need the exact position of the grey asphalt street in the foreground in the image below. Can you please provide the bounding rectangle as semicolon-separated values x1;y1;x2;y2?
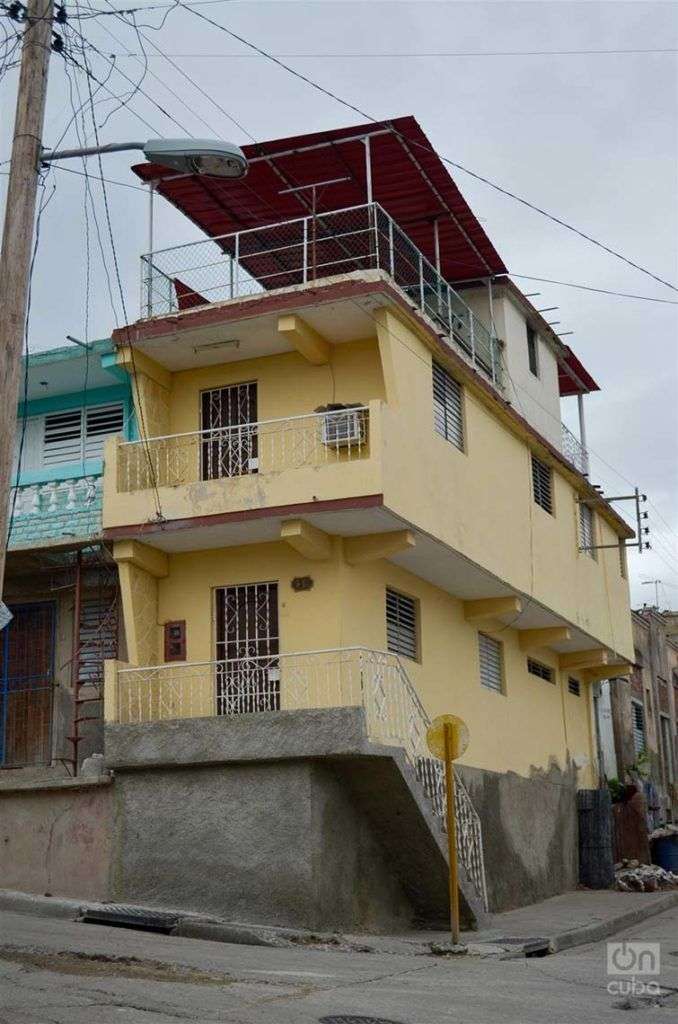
0;908;678;1024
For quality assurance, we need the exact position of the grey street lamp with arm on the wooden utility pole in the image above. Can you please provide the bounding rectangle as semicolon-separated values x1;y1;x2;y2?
40;138;247;178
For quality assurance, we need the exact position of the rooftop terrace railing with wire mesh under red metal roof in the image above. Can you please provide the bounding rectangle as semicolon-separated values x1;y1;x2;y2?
141;203;502;387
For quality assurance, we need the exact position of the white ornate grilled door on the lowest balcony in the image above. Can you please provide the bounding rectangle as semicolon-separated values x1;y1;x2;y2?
216;583;281;715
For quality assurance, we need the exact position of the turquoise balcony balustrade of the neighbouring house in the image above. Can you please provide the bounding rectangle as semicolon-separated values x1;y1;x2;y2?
9;475;101;549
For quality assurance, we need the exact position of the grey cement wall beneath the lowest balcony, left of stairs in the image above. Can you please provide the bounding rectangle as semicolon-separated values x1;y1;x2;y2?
113;761;413;931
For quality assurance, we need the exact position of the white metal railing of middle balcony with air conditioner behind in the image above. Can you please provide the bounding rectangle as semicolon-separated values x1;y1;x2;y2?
118;406;370;493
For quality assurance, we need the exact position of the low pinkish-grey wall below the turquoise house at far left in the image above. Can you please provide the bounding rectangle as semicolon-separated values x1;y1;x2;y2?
0;780;113;899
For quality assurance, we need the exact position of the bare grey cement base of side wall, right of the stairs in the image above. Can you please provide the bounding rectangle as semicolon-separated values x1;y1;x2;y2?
458;766;579;911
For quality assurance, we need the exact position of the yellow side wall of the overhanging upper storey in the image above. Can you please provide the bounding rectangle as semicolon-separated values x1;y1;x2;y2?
380;314;633;657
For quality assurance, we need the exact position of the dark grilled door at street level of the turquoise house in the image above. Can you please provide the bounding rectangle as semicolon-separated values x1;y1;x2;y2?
0;601;55;766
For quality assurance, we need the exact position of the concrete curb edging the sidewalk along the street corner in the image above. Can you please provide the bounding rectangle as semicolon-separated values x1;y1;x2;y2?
0;889;678;959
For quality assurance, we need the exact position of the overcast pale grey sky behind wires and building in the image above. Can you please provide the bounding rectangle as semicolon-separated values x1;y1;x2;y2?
0;0;678;607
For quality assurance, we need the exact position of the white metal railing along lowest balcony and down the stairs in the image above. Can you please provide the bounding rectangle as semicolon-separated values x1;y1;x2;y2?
115;647;488;908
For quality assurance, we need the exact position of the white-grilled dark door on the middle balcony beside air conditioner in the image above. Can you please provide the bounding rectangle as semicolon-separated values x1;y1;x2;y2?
201;382;258;480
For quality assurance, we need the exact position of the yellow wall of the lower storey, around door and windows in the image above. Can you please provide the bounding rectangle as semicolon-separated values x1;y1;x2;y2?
116;540;595;785
